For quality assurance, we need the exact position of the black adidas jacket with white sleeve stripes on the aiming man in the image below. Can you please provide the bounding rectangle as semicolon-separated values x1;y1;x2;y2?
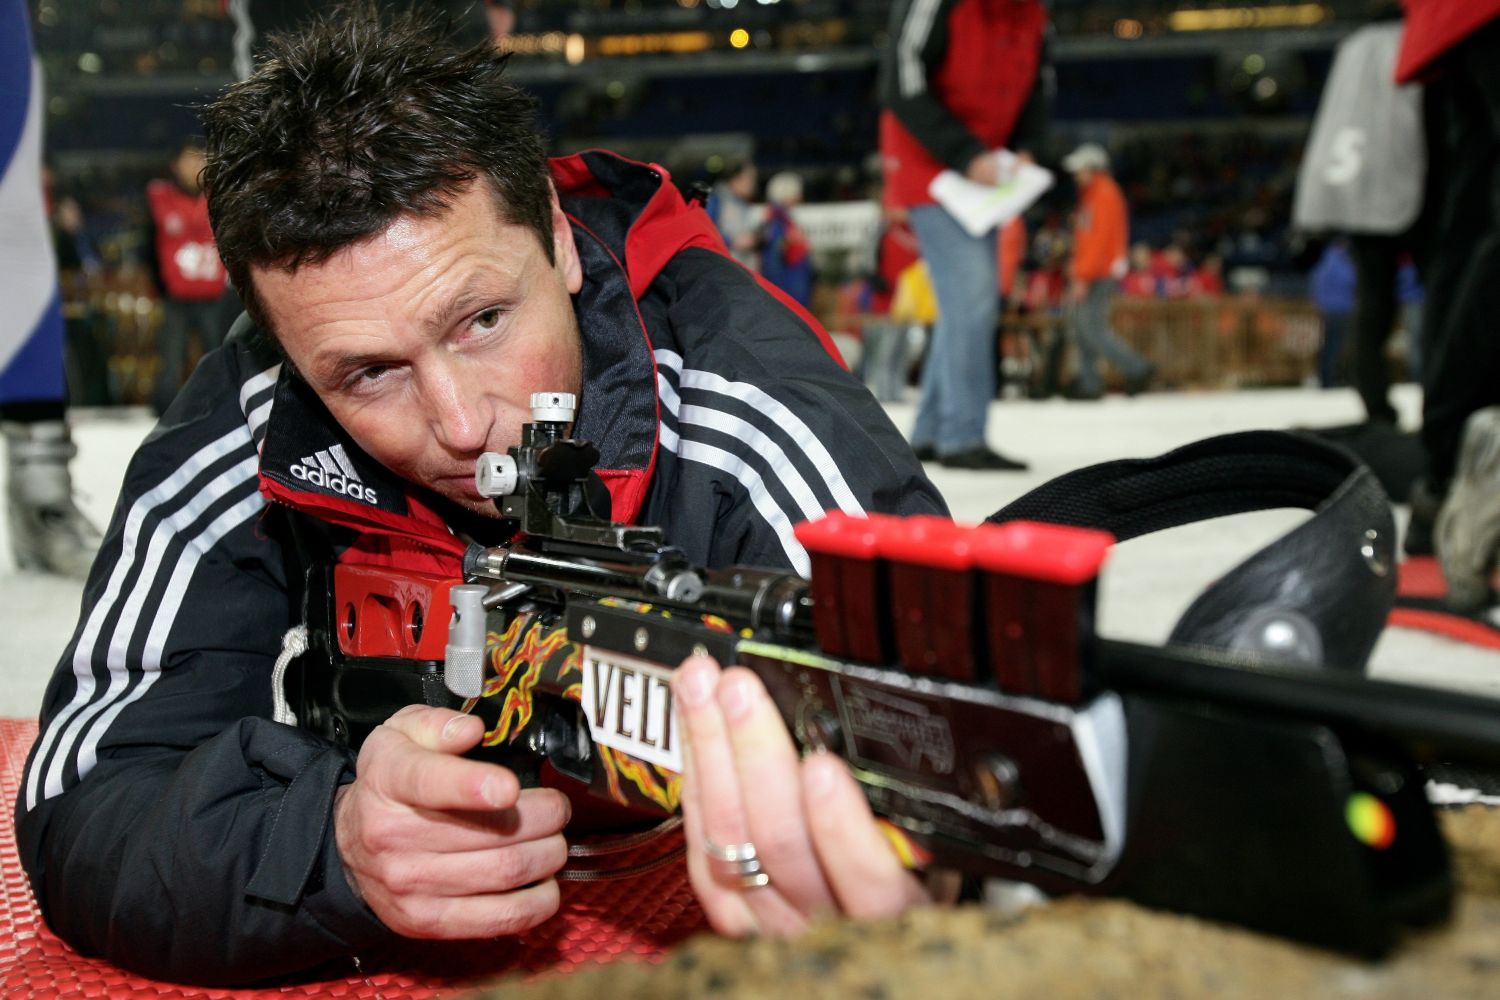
17;153;944;984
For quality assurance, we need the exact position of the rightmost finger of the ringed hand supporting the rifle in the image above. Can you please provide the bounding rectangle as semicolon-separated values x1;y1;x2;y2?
803;753;930;918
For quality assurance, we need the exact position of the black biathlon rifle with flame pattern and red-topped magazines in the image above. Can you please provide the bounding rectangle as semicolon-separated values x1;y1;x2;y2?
284;393;1500;955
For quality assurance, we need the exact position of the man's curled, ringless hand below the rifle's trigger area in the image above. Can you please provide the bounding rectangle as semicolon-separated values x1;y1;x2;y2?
333;705;572;939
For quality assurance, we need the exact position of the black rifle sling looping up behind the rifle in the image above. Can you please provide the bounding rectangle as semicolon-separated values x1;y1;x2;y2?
989;430;1397;670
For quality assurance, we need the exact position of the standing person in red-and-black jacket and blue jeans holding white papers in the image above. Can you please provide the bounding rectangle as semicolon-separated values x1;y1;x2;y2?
881;0;1049;469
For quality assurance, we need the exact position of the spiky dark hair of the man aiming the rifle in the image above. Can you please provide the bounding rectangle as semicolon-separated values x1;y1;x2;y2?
203;1;552;331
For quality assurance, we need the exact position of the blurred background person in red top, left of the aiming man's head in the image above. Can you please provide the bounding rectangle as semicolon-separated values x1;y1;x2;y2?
146;139;239;415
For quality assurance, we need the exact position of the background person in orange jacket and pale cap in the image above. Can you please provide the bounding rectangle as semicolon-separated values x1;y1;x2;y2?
1062;142;1155;399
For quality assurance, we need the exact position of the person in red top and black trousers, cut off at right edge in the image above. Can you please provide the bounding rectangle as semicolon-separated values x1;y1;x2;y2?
1395;0;1500;606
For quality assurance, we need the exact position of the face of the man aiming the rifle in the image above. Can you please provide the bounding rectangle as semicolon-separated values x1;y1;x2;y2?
252;181;584;514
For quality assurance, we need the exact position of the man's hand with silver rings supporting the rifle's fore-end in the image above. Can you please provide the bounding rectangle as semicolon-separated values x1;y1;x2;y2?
672;657;930;936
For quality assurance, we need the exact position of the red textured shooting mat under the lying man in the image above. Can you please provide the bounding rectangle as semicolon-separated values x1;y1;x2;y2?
0;718;705;1000
